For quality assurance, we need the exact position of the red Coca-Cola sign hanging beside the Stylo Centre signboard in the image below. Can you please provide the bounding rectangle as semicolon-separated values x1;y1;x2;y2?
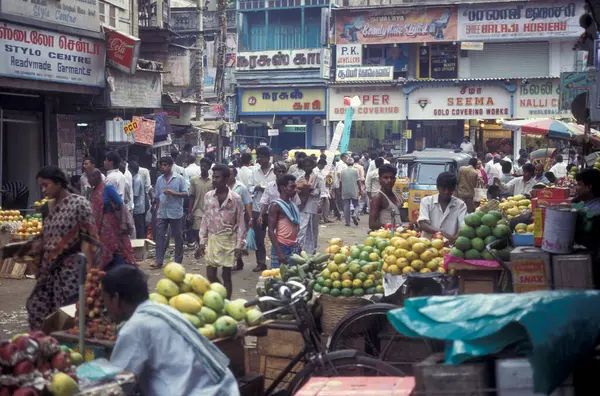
104;28;140;74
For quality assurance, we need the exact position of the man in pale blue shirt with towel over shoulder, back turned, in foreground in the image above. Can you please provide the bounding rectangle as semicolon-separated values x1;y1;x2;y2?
102;265;240;396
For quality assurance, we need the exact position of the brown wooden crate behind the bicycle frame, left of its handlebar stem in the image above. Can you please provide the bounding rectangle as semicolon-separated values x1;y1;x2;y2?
256;325;304;388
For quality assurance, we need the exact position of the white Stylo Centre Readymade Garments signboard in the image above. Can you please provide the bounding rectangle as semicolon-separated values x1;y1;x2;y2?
0;24;106;87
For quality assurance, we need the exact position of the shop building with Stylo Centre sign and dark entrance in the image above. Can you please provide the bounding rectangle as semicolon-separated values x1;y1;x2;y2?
0;0;106;209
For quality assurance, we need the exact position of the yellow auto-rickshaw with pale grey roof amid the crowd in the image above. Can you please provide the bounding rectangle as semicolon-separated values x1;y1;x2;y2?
395;148;471;222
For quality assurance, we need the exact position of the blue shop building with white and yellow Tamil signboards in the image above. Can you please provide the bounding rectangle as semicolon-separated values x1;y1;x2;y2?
233;0;330;153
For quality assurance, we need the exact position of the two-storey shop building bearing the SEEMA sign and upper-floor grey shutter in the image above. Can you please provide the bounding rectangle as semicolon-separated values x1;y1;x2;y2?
328;0;584;157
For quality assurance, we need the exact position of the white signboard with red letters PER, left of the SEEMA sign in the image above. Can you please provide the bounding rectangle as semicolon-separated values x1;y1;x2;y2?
328;85;406;121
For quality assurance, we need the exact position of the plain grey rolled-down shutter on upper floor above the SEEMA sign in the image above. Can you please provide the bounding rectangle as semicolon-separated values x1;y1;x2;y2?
467;41;550;78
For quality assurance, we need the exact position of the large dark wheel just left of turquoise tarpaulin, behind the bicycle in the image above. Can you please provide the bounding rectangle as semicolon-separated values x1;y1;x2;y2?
328;304;438;375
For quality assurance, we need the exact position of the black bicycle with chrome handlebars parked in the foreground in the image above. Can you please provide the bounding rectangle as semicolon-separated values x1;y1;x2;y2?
245;281;403;396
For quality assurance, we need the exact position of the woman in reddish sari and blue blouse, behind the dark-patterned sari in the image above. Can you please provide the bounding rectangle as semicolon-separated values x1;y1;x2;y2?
88;169;135;271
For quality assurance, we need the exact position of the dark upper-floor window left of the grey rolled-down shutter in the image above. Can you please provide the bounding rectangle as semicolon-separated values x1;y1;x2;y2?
417;44;458;79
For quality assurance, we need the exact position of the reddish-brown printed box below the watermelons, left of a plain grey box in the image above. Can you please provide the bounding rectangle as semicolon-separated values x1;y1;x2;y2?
510;246;552;293
